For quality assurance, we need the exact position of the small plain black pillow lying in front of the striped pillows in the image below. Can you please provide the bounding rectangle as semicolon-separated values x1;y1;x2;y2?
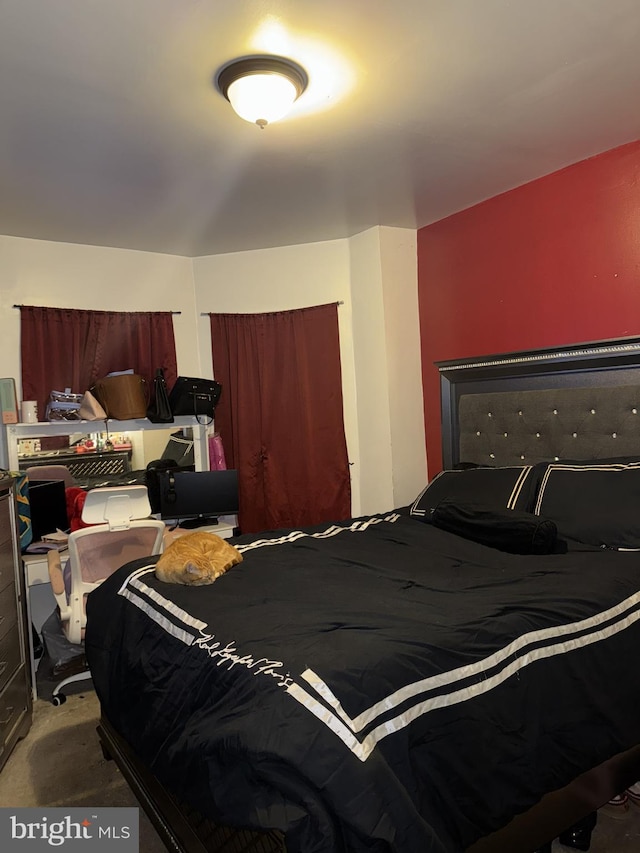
425;499;566;554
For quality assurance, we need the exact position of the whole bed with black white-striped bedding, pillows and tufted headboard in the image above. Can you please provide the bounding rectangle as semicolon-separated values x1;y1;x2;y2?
86;339;640;853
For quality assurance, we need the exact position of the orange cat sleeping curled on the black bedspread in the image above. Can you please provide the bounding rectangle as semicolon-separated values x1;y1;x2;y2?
156;531;242;586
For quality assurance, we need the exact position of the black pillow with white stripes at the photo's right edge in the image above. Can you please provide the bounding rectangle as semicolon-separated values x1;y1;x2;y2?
534;460;640;548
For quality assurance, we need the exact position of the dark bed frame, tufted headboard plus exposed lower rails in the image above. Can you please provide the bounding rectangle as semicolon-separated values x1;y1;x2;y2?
98;338;640;853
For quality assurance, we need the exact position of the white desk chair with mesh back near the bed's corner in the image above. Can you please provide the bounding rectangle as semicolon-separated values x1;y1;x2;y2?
47;486;165;705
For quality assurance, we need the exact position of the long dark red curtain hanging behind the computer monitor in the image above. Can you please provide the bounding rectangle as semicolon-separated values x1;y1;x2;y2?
210;304;351;533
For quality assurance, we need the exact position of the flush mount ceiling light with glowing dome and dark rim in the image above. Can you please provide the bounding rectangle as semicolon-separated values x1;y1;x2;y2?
216;56;309;128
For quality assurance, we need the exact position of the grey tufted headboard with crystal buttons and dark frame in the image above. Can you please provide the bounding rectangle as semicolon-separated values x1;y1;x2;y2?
437;338;640;468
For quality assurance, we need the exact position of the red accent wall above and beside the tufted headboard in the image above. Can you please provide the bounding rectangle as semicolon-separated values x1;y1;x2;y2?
418;141;640;477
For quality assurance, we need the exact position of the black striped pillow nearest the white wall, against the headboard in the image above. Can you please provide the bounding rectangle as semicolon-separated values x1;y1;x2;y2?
411;465;542;519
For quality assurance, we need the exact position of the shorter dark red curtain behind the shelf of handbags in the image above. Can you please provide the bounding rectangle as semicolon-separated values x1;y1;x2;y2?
20;305;178;420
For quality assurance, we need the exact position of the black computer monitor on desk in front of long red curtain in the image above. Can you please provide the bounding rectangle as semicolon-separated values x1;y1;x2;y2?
158;469;239;528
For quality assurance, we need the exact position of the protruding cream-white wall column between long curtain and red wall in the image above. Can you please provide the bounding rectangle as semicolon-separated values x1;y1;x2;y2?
350;227;427;514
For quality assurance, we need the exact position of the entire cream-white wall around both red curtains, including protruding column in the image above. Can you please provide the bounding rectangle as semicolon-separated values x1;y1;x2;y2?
0;228;426;515
